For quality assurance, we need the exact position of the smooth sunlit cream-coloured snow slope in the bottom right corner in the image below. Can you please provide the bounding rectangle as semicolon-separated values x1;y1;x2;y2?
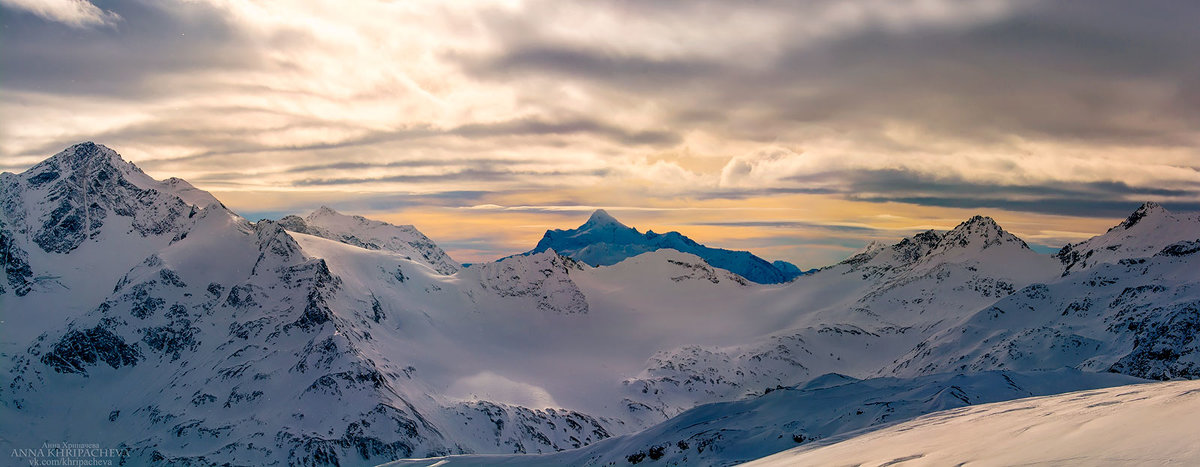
746;381;1200;467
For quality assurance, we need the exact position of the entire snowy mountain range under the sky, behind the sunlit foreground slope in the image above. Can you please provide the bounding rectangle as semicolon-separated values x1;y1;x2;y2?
0;143;1200;465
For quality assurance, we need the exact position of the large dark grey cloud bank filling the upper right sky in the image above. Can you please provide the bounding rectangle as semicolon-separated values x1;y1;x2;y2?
462;0;1200;145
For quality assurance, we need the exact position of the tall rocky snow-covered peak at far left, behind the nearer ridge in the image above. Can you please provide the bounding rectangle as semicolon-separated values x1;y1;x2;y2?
0;143;202;338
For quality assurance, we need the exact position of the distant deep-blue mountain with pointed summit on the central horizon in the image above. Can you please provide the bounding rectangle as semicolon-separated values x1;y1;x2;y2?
524;209;803;283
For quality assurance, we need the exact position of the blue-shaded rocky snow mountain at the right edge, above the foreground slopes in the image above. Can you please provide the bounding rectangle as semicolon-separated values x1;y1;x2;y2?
890;203;1200;379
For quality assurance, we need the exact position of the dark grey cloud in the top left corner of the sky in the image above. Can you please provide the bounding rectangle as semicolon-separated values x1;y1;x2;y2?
0;0;262;98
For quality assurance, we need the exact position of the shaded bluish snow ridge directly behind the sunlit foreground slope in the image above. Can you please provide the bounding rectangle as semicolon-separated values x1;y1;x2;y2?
392;369;1140;466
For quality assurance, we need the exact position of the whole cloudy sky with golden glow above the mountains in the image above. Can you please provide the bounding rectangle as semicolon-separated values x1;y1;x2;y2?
0;0;1200;267
